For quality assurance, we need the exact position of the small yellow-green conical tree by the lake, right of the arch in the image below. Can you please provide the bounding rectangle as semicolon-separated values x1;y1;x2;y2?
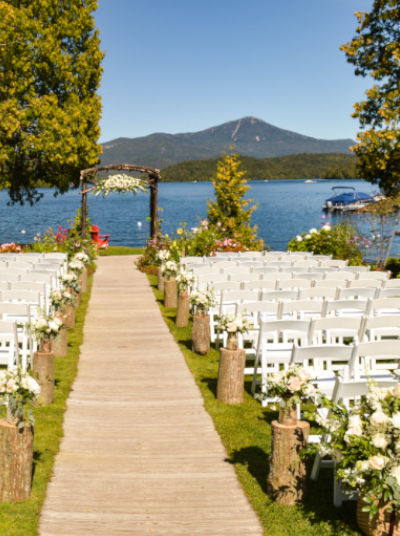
208;154;261;249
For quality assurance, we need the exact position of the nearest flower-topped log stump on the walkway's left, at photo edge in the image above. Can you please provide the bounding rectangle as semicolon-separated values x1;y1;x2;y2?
0;369;40;502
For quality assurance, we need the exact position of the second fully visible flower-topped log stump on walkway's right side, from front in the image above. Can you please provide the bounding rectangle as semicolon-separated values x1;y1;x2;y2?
216;315;251;404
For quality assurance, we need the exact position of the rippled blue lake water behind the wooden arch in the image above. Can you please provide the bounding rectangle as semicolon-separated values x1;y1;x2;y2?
0;180;400;255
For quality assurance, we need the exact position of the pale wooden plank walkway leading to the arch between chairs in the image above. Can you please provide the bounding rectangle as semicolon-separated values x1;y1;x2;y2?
39;256;262;536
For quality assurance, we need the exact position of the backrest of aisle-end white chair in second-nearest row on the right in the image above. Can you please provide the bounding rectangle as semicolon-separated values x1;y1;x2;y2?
290;344;353;377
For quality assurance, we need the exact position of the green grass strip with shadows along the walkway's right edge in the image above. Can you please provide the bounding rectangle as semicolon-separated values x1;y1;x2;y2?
148;276;360;536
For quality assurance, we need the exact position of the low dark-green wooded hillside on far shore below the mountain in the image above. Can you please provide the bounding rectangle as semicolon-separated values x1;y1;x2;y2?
161;154;357;182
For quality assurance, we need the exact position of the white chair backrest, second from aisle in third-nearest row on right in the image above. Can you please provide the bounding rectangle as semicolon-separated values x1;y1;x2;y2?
309;316;363;344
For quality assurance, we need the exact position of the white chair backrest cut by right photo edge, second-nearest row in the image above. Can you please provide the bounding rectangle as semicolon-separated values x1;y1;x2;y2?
350;340;400;379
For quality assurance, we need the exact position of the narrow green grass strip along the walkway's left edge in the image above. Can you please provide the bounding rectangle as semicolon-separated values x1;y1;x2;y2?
0;276;93;536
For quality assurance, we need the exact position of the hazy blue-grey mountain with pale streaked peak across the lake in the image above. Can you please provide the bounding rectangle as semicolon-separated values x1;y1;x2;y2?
100;117;354;169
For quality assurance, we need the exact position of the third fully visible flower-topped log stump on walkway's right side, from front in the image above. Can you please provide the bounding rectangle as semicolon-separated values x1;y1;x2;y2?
189;289;216;355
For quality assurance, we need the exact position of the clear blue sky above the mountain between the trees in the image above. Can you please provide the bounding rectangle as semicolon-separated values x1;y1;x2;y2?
95;0;372;142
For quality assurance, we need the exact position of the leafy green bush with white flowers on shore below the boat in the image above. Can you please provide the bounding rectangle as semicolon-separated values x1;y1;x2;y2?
287;224;362;265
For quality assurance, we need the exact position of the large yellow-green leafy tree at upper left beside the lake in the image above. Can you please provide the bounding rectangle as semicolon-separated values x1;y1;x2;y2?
0;0;103;203
